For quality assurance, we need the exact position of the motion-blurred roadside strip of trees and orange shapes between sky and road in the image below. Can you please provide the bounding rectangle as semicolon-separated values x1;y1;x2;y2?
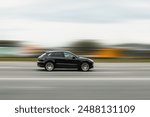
0;39;150;62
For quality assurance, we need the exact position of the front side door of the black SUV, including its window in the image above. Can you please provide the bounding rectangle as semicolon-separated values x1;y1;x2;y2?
64;52;79;68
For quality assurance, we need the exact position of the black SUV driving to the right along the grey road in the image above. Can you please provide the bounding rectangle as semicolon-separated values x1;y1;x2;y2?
37;51;94;71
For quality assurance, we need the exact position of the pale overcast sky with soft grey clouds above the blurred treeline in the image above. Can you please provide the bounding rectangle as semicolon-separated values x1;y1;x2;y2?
0;0;150;47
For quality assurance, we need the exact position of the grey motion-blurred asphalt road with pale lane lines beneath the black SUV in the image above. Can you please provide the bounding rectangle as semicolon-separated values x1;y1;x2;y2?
0;62;150;100
